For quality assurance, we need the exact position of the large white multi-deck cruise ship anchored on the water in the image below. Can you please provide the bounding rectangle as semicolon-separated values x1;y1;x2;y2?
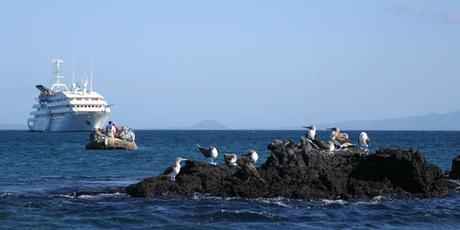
27;59;110;132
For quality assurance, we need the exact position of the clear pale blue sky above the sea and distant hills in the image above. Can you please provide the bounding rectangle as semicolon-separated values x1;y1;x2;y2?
0;0;460;128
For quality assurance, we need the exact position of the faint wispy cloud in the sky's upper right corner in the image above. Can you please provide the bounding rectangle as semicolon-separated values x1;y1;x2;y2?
385;4;460;25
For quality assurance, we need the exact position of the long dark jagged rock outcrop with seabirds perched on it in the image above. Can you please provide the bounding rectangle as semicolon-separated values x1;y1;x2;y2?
126;140;458;199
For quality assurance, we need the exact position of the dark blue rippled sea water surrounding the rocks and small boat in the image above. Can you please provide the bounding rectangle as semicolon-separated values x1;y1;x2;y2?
0;131;460;229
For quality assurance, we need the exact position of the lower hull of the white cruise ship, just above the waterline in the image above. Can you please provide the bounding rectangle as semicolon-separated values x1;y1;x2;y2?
29;112;109;132
